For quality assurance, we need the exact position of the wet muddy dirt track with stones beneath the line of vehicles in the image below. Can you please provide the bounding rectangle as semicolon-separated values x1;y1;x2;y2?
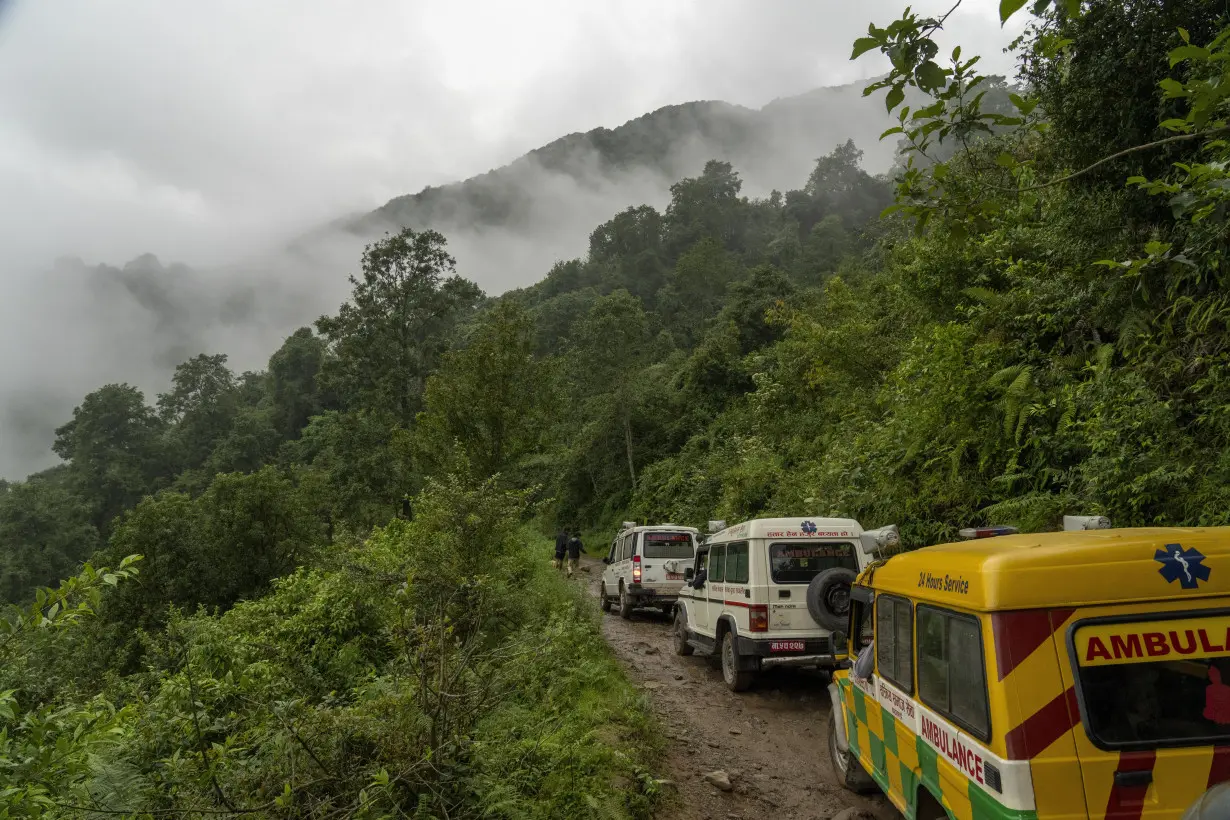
581;561;900;820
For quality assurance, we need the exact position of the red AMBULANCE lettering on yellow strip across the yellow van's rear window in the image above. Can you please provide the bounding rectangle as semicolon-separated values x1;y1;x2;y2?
1076;616;1230;666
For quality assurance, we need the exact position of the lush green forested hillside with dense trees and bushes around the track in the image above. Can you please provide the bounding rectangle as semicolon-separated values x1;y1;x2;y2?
0;0;1230;818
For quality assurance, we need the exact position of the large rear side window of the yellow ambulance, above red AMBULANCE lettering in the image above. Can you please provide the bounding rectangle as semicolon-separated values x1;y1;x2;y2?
918;604;991;740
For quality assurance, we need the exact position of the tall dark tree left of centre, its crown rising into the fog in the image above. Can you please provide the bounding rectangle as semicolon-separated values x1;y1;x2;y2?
316;227;482;429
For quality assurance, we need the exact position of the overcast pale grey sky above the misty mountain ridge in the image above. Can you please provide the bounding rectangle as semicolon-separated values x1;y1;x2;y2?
0;0;1016;269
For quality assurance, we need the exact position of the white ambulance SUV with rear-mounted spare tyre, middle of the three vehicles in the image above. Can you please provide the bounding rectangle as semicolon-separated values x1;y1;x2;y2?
674;518;900;692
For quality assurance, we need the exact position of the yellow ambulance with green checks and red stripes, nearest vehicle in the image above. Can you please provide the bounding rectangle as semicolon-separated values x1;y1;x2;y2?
830;527;1230;820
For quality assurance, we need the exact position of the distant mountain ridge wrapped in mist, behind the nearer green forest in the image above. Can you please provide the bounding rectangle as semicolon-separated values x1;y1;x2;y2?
335;81;894;242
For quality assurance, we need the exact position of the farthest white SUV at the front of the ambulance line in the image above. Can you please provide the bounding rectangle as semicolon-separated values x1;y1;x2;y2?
599;521;700;618
